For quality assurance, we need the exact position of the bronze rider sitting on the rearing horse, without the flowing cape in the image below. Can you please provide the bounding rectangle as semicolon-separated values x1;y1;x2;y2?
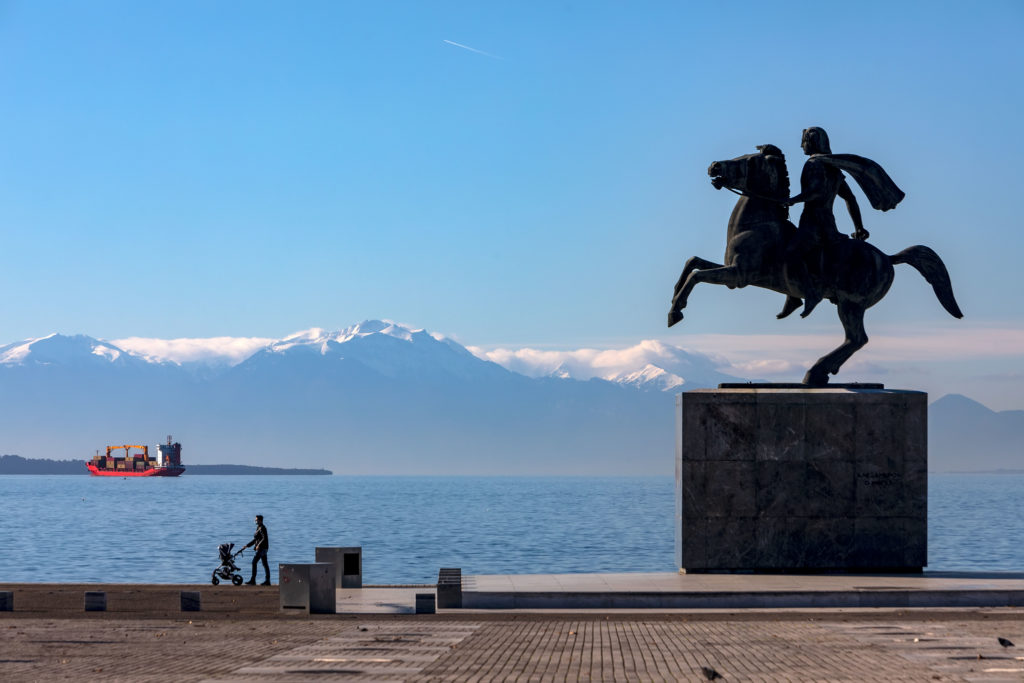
788;127;868;317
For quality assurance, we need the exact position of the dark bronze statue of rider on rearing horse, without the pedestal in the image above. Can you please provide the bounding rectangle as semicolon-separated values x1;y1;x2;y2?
669;128;964;386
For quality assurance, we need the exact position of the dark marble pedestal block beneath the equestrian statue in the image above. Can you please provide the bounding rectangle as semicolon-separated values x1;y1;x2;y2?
676;385;928;572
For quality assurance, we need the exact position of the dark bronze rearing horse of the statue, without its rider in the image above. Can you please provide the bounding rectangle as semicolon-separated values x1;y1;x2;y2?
669;144;964;386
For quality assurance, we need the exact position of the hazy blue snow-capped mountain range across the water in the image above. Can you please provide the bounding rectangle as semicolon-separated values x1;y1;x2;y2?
0;321;1024;475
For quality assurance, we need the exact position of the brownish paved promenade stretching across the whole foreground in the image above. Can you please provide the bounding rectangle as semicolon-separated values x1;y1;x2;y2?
0;586;1024;682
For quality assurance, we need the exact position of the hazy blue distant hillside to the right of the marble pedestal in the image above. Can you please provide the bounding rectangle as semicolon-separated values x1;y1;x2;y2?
928;394;1024;472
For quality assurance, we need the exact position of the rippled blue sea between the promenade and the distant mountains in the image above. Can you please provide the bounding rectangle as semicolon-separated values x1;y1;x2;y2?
0;473;1024;585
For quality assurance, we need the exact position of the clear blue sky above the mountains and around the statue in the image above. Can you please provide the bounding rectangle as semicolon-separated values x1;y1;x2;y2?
0;0;1024;410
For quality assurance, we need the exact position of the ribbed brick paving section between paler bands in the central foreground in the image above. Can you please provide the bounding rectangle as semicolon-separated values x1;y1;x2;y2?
413;621;991;681
